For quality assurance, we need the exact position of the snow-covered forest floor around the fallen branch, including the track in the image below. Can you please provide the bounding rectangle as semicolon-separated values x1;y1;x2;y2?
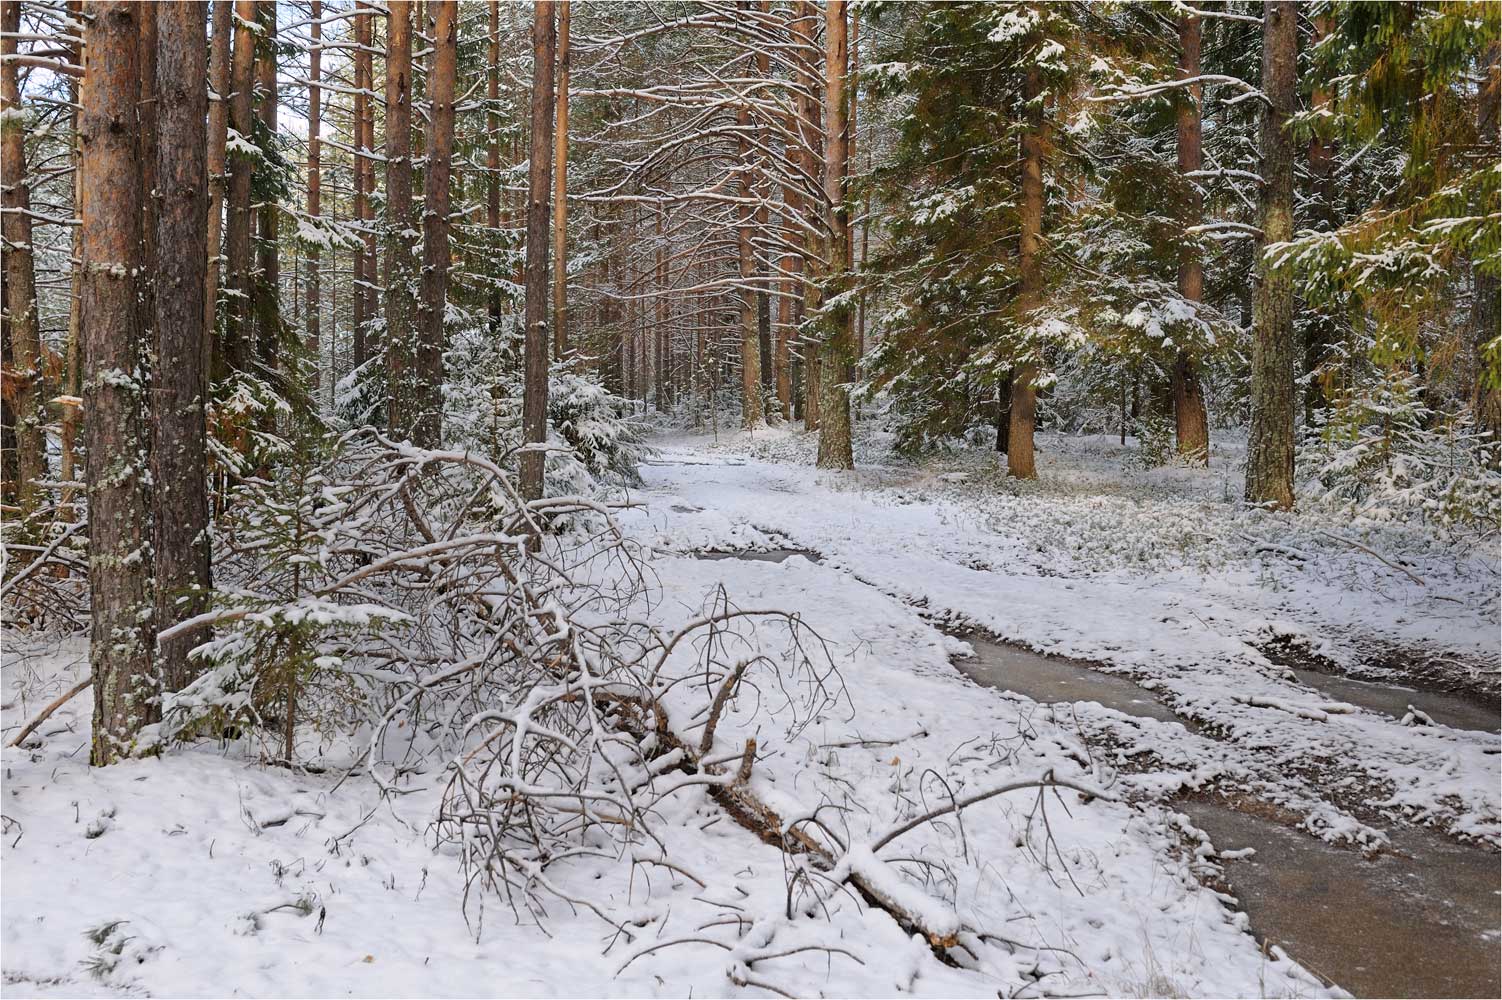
0;429;1502;997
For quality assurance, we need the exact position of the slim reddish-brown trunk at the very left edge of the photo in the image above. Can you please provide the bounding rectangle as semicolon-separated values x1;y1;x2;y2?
0;0;47;518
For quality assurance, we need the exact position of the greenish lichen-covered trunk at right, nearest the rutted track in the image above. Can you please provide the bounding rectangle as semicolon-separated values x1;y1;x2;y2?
1247;0;1299;511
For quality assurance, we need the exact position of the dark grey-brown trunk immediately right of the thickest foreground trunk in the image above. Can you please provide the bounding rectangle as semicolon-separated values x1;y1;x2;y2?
152;0;213;691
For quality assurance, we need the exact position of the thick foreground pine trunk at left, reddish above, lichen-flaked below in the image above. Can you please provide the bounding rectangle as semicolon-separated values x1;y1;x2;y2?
80;0;156;764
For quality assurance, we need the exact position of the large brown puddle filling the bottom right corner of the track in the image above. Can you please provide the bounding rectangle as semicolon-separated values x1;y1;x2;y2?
1173;799;1502;997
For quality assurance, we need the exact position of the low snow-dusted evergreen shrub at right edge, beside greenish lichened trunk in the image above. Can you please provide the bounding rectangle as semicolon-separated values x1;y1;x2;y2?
1298;372;1502;535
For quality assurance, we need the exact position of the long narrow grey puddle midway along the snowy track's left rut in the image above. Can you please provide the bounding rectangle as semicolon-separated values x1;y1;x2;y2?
954;635;1182;722
